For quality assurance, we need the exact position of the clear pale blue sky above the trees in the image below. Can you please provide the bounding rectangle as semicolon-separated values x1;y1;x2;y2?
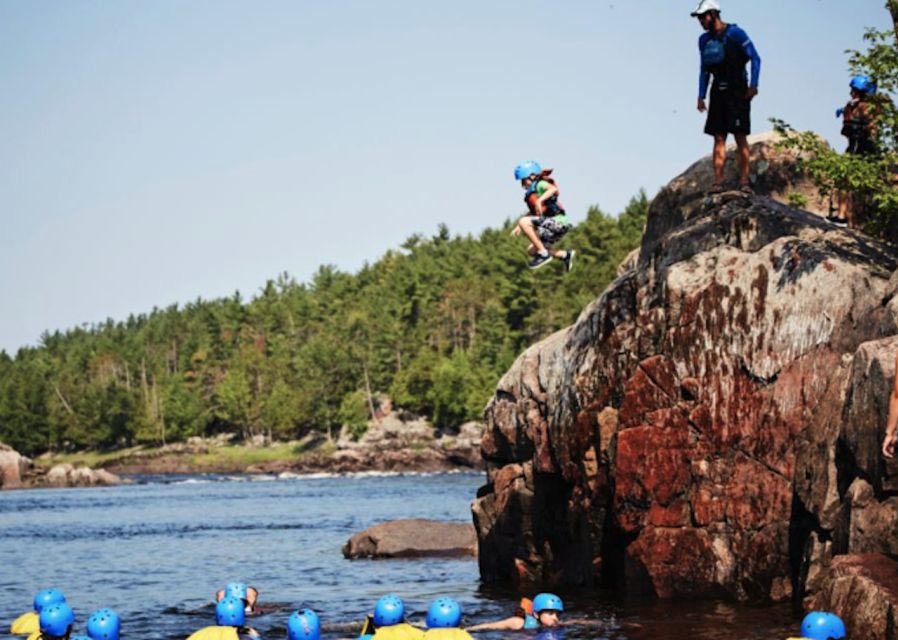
0;0;890;353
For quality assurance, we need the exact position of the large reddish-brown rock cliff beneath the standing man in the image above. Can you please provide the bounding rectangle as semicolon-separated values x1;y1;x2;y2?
473;138;898;600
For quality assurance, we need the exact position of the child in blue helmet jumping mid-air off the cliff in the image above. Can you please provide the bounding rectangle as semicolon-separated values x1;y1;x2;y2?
511;160;575;271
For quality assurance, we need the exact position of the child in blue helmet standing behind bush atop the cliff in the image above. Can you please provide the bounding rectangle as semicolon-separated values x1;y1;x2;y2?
827;75;881;227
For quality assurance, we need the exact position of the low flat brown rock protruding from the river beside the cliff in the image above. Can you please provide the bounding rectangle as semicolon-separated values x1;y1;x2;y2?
343;518;477;558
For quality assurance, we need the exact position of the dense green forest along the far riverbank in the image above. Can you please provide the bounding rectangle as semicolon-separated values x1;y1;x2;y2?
0;192;648;455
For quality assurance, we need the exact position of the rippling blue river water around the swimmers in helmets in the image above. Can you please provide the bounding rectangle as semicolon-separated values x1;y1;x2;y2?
0;474;800;640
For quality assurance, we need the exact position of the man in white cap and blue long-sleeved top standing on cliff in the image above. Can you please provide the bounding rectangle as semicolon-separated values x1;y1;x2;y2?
691;0;761;194
